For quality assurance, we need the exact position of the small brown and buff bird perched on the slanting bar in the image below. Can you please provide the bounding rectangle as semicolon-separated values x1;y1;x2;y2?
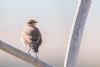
21;19;42;57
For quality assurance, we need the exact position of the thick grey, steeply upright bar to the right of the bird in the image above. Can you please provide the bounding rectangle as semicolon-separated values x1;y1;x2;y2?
64;0;91;67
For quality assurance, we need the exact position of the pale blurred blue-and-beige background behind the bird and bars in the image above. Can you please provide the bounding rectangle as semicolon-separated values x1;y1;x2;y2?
0;0;100;67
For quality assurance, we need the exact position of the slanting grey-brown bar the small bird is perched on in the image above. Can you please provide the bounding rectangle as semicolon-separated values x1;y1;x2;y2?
0;40;54;67
